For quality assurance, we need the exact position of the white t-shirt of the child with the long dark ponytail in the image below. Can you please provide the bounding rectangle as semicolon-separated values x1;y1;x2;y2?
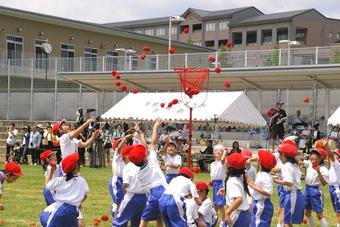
226;177;249;211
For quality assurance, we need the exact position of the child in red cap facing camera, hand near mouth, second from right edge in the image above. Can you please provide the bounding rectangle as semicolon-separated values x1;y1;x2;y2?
304;148;328;227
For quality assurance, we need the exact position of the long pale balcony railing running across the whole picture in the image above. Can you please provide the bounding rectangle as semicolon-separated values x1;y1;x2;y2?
0;46;340;77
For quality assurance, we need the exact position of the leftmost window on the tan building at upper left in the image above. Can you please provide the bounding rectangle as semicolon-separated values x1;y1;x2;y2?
6;35;23;65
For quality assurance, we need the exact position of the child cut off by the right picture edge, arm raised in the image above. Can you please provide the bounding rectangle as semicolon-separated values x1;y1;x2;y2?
325;143;340;227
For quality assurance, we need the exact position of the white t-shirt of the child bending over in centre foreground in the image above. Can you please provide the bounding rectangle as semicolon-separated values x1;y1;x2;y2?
164;176;198;198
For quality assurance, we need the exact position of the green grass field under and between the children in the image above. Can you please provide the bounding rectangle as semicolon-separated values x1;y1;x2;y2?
0;165;336;226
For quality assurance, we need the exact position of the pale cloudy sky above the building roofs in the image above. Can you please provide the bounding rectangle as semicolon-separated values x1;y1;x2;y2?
0;0;340;23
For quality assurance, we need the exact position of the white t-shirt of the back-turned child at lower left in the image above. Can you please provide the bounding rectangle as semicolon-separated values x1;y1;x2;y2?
46;176;89;207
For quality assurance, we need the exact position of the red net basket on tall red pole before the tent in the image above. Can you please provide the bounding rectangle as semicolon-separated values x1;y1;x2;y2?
174;68;209;168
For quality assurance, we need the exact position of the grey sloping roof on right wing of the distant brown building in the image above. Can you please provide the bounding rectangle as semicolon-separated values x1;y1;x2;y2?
230;9;314;27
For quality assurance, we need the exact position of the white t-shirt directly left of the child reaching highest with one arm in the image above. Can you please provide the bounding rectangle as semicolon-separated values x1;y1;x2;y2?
123;162;148;194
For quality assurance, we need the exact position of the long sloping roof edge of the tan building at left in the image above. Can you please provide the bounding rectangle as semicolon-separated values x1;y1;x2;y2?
0;6;212;52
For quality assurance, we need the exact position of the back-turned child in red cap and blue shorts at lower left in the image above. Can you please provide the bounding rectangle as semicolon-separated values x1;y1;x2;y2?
40;153;89;227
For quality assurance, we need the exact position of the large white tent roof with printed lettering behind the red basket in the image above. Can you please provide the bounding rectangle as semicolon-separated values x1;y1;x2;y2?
102;92;267;127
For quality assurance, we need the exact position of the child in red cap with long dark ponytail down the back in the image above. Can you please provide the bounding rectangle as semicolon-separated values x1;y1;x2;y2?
223;153;250;226
